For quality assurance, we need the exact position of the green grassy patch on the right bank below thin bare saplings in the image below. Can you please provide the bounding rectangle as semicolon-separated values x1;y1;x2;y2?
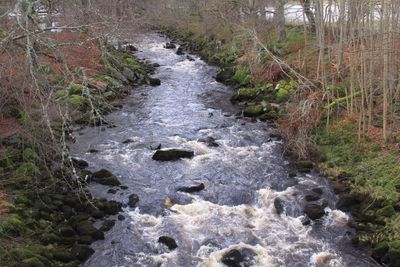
317;121;400;245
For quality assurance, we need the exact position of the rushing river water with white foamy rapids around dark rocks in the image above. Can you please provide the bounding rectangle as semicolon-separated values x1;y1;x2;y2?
72;34;375;267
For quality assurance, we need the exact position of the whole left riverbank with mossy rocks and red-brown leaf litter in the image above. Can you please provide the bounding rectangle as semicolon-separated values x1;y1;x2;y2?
0;32;160;267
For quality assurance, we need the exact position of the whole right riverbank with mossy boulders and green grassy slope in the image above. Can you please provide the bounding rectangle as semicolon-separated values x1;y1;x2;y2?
165;26;400;266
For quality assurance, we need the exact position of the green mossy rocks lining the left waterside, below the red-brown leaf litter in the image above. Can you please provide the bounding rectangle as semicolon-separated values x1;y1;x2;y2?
0;40;160;267
